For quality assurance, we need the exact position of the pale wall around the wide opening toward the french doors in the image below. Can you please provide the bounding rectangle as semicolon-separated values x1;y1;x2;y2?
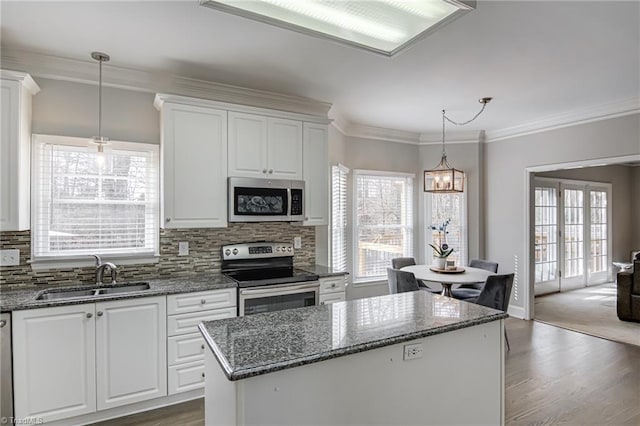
485;114;640;316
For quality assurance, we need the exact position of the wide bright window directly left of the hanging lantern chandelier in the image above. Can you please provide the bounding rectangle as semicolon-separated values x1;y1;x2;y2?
353;170;414;282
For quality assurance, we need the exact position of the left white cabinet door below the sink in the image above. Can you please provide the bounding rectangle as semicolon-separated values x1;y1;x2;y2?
13;304;96;422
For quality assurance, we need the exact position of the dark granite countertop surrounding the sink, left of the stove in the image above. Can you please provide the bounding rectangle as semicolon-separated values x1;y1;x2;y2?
0;273;237;312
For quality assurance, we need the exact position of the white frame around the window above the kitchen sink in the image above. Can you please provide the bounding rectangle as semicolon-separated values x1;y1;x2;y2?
29;134;160;270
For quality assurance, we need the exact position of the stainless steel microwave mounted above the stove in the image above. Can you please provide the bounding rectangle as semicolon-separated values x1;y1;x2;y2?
229;177;305;222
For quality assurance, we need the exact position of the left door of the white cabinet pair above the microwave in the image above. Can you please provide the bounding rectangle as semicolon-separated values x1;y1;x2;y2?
228;111;267;178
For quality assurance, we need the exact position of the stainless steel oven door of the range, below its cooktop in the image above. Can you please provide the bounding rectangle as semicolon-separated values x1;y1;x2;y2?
238;281;320;316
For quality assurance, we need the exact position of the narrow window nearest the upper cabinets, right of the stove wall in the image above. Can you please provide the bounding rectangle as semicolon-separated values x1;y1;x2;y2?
331;164;349;271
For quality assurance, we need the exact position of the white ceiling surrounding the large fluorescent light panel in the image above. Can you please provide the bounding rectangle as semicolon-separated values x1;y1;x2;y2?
0;0;640;133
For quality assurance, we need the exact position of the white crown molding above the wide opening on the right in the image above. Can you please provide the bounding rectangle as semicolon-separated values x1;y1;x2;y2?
486;97;640;143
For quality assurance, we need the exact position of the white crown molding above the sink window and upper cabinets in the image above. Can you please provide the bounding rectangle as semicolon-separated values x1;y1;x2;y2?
1;49;331;119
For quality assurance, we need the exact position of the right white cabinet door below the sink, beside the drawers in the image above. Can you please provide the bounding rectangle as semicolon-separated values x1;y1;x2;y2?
95;296;167;410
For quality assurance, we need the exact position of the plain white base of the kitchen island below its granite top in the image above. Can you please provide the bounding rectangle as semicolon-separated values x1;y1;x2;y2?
205;320;504;426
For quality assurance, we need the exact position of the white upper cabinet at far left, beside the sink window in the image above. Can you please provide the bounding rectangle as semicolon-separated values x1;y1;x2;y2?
0;70;40;231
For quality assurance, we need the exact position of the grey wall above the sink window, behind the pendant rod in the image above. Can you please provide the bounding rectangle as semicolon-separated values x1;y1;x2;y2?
32;78;160;143
